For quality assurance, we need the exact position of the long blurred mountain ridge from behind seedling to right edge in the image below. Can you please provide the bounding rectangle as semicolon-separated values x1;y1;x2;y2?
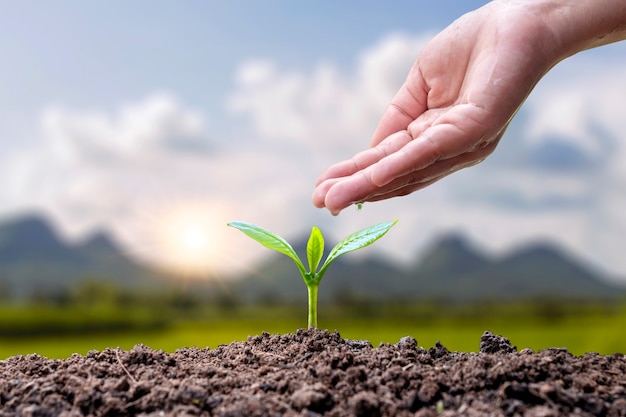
236;234;626;301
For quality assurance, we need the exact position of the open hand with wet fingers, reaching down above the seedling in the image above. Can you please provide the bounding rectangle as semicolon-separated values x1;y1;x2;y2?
313;2;563;215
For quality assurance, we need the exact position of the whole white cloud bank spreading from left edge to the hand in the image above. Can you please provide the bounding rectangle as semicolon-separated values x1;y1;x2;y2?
0;35;436;276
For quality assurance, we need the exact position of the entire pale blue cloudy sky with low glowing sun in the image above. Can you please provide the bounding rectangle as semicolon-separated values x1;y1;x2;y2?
0;0;626;282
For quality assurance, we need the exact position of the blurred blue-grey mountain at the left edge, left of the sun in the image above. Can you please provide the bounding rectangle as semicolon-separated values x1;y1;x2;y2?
0;215;165;299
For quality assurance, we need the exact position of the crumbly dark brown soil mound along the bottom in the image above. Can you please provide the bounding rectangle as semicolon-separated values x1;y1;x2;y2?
0;329;626;417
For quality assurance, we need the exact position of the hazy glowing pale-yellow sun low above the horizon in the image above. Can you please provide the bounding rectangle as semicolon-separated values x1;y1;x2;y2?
157;204;228;277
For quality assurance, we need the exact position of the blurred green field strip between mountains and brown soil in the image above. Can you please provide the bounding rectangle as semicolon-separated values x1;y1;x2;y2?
0;300;626;359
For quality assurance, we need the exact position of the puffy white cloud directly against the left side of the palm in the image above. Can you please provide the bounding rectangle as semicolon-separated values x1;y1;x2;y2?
228;34;429;157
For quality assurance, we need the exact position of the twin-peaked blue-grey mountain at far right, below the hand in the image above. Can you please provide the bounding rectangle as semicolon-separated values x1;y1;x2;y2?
398;235;626;300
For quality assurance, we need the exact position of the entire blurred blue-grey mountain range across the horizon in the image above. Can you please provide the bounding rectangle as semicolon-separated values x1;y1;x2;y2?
0;216;626;301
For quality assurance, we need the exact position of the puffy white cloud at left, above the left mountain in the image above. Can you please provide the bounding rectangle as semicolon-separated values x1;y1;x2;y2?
2;93;211;239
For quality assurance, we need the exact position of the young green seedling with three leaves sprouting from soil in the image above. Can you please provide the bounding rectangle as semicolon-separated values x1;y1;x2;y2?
228;220;398;327
